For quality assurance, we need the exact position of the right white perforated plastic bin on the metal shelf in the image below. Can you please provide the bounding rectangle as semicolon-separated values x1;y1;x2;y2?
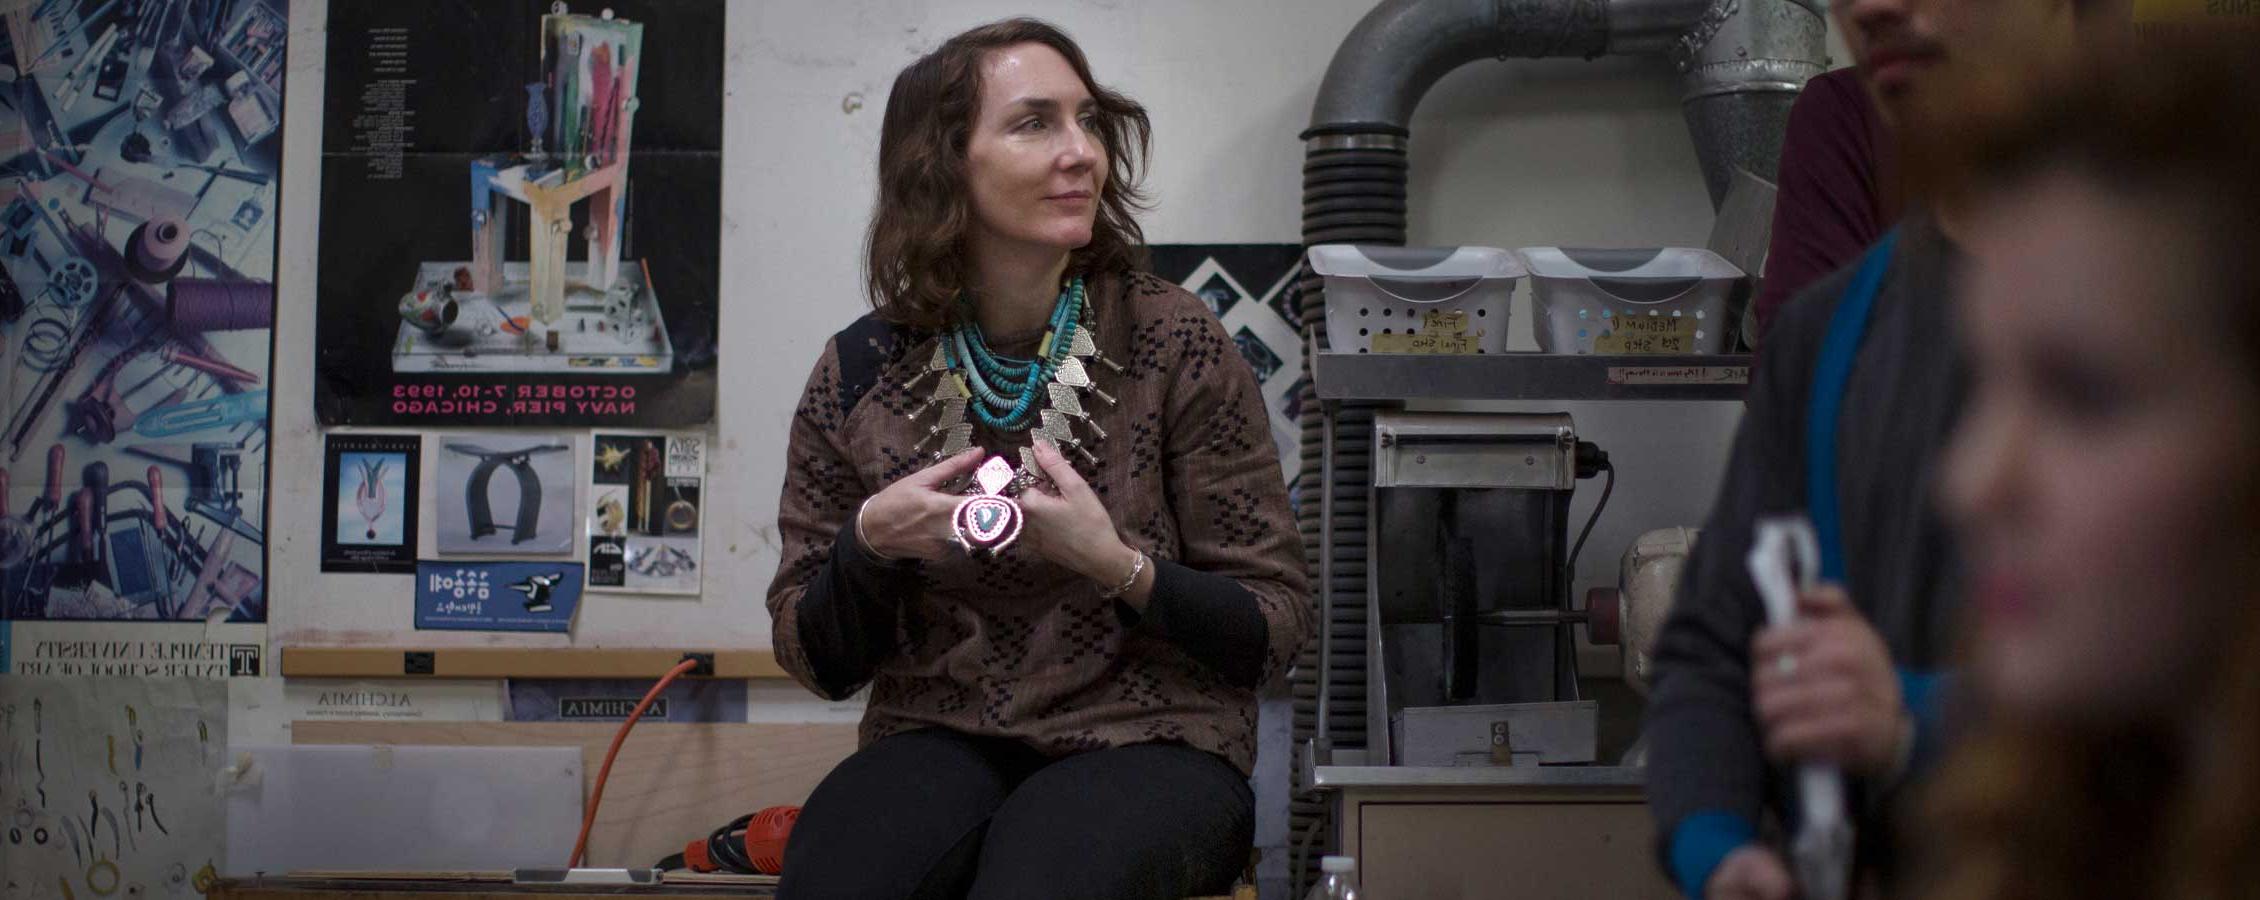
1516;246;1742;355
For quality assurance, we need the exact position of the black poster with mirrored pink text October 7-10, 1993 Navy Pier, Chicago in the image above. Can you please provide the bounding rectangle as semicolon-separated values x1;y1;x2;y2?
314;0;723;427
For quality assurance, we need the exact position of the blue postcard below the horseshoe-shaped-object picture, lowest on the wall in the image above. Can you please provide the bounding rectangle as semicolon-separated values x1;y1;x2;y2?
416;559;581;631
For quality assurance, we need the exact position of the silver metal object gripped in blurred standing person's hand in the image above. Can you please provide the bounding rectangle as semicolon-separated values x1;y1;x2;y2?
1747;516;1853;900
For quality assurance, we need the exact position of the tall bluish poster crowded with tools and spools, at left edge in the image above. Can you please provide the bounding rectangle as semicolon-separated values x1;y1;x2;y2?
0;0;289;622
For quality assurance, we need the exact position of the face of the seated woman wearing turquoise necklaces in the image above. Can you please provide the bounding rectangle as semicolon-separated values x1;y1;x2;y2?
965;43;1107;253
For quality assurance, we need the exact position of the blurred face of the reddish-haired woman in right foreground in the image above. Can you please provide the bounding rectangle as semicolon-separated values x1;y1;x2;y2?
1946;172;2255;719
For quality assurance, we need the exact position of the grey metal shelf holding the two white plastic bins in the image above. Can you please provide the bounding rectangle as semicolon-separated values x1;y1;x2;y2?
1311;351;1752;400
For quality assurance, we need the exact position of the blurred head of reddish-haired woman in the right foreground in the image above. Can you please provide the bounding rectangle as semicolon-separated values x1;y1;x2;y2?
1916;38;2260;900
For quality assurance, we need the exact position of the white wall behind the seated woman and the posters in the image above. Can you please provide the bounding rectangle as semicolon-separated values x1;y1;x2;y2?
271;0;1835;647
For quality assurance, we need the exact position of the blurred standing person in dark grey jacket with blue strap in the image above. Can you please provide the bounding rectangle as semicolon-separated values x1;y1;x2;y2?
1645;0;2127;900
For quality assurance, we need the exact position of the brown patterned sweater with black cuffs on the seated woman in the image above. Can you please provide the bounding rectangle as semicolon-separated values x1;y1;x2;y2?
768;274;1311;771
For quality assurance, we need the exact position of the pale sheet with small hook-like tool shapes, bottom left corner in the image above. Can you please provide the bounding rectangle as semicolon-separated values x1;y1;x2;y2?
0;676;228;900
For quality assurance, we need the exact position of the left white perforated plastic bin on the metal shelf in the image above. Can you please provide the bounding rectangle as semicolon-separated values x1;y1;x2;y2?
1311;244;1523;353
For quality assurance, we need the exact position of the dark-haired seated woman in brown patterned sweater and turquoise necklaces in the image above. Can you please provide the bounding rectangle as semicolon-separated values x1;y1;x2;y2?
768;20;1311;900
